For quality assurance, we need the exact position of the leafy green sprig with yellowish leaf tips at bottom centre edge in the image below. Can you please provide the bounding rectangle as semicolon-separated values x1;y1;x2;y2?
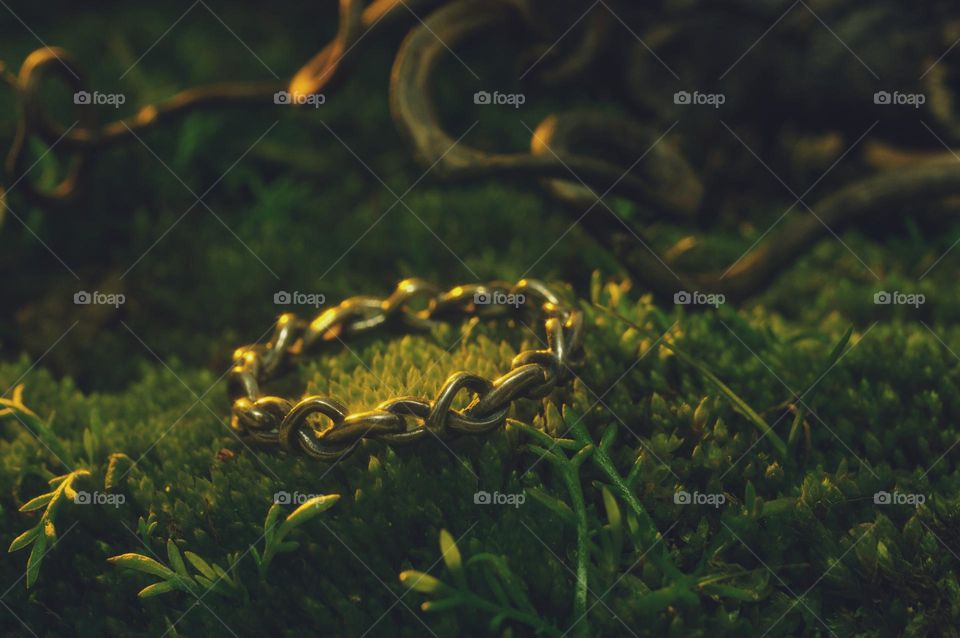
400;530;564;636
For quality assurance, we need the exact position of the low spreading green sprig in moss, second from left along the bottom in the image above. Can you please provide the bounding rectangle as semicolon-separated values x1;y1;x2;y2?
107;540;243;598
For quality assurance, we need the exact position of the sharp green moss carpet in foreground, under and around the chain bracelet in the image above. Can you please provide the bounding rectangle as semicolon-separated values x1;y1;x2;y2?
0;287;960;635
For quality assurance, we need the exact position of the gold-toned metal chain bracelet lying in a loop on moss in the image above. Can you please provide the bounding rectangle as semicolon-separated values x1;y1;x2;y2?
228;279;583;461
